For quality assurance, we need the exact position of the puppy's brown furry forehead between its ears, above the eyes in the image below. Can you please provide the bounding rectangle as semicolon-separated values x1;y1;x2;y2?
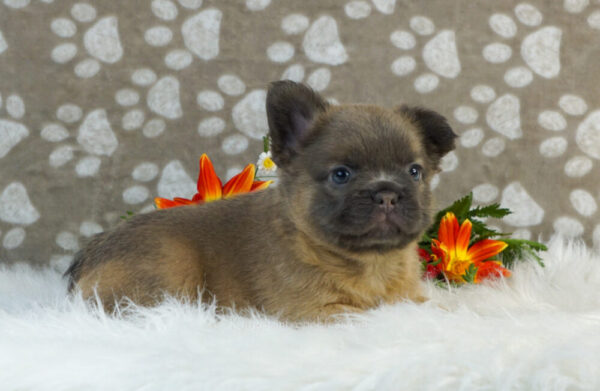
304;106;423;169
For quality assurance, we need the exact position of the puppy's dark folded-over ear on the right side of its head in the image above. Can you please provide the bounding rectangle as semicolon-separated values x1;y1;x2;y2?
396;105;457;168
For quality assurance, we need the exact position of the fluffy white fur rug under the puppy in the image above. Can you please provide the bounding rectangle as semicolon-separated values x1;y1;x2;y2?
0;240;600;391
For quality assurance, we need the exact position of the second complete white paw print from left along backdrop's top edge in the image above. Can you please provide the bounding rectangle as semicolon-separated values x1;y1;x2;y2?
144;0;223;71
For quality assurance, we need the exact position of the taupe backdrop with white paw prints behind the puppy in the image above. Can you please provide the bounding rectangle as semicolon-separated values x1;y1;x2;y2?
0;0;600;267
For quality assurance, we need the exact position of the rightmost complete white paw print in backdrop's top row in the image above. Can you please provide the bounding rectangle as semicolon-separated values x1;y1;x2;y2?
482;3;562;88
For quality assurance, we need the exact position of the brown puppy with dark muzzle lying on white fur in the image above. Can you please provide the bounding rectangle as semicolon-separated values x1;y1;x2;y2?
66;81;456;321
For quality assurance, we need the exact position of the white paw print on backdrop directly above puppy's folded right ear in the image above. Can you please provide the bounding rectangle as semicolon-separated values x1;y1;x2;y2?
390;15;461;94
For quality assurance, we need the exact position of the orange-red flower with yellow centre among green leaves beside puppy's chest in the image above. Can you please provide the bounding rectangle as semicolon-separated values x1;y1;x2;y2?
431;212;510;283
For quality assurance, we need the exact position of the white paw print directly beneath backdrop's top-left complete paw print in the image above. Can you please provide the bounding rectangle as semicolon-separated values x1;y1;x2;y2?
40;103;119;178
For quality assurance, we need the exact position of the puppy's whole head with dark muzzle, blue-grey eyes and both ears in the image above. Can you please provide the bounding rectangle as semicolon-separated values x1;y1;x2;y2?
267;81;456;252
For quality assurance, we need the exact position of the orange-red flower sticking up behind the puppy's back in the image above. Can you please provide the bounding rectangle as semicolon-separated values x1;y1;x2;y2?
154;154;273;209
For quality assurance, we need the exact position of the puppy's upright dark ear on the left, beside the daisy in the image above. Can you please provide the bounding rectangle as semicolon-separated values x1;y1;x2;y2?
267;80;328;166
